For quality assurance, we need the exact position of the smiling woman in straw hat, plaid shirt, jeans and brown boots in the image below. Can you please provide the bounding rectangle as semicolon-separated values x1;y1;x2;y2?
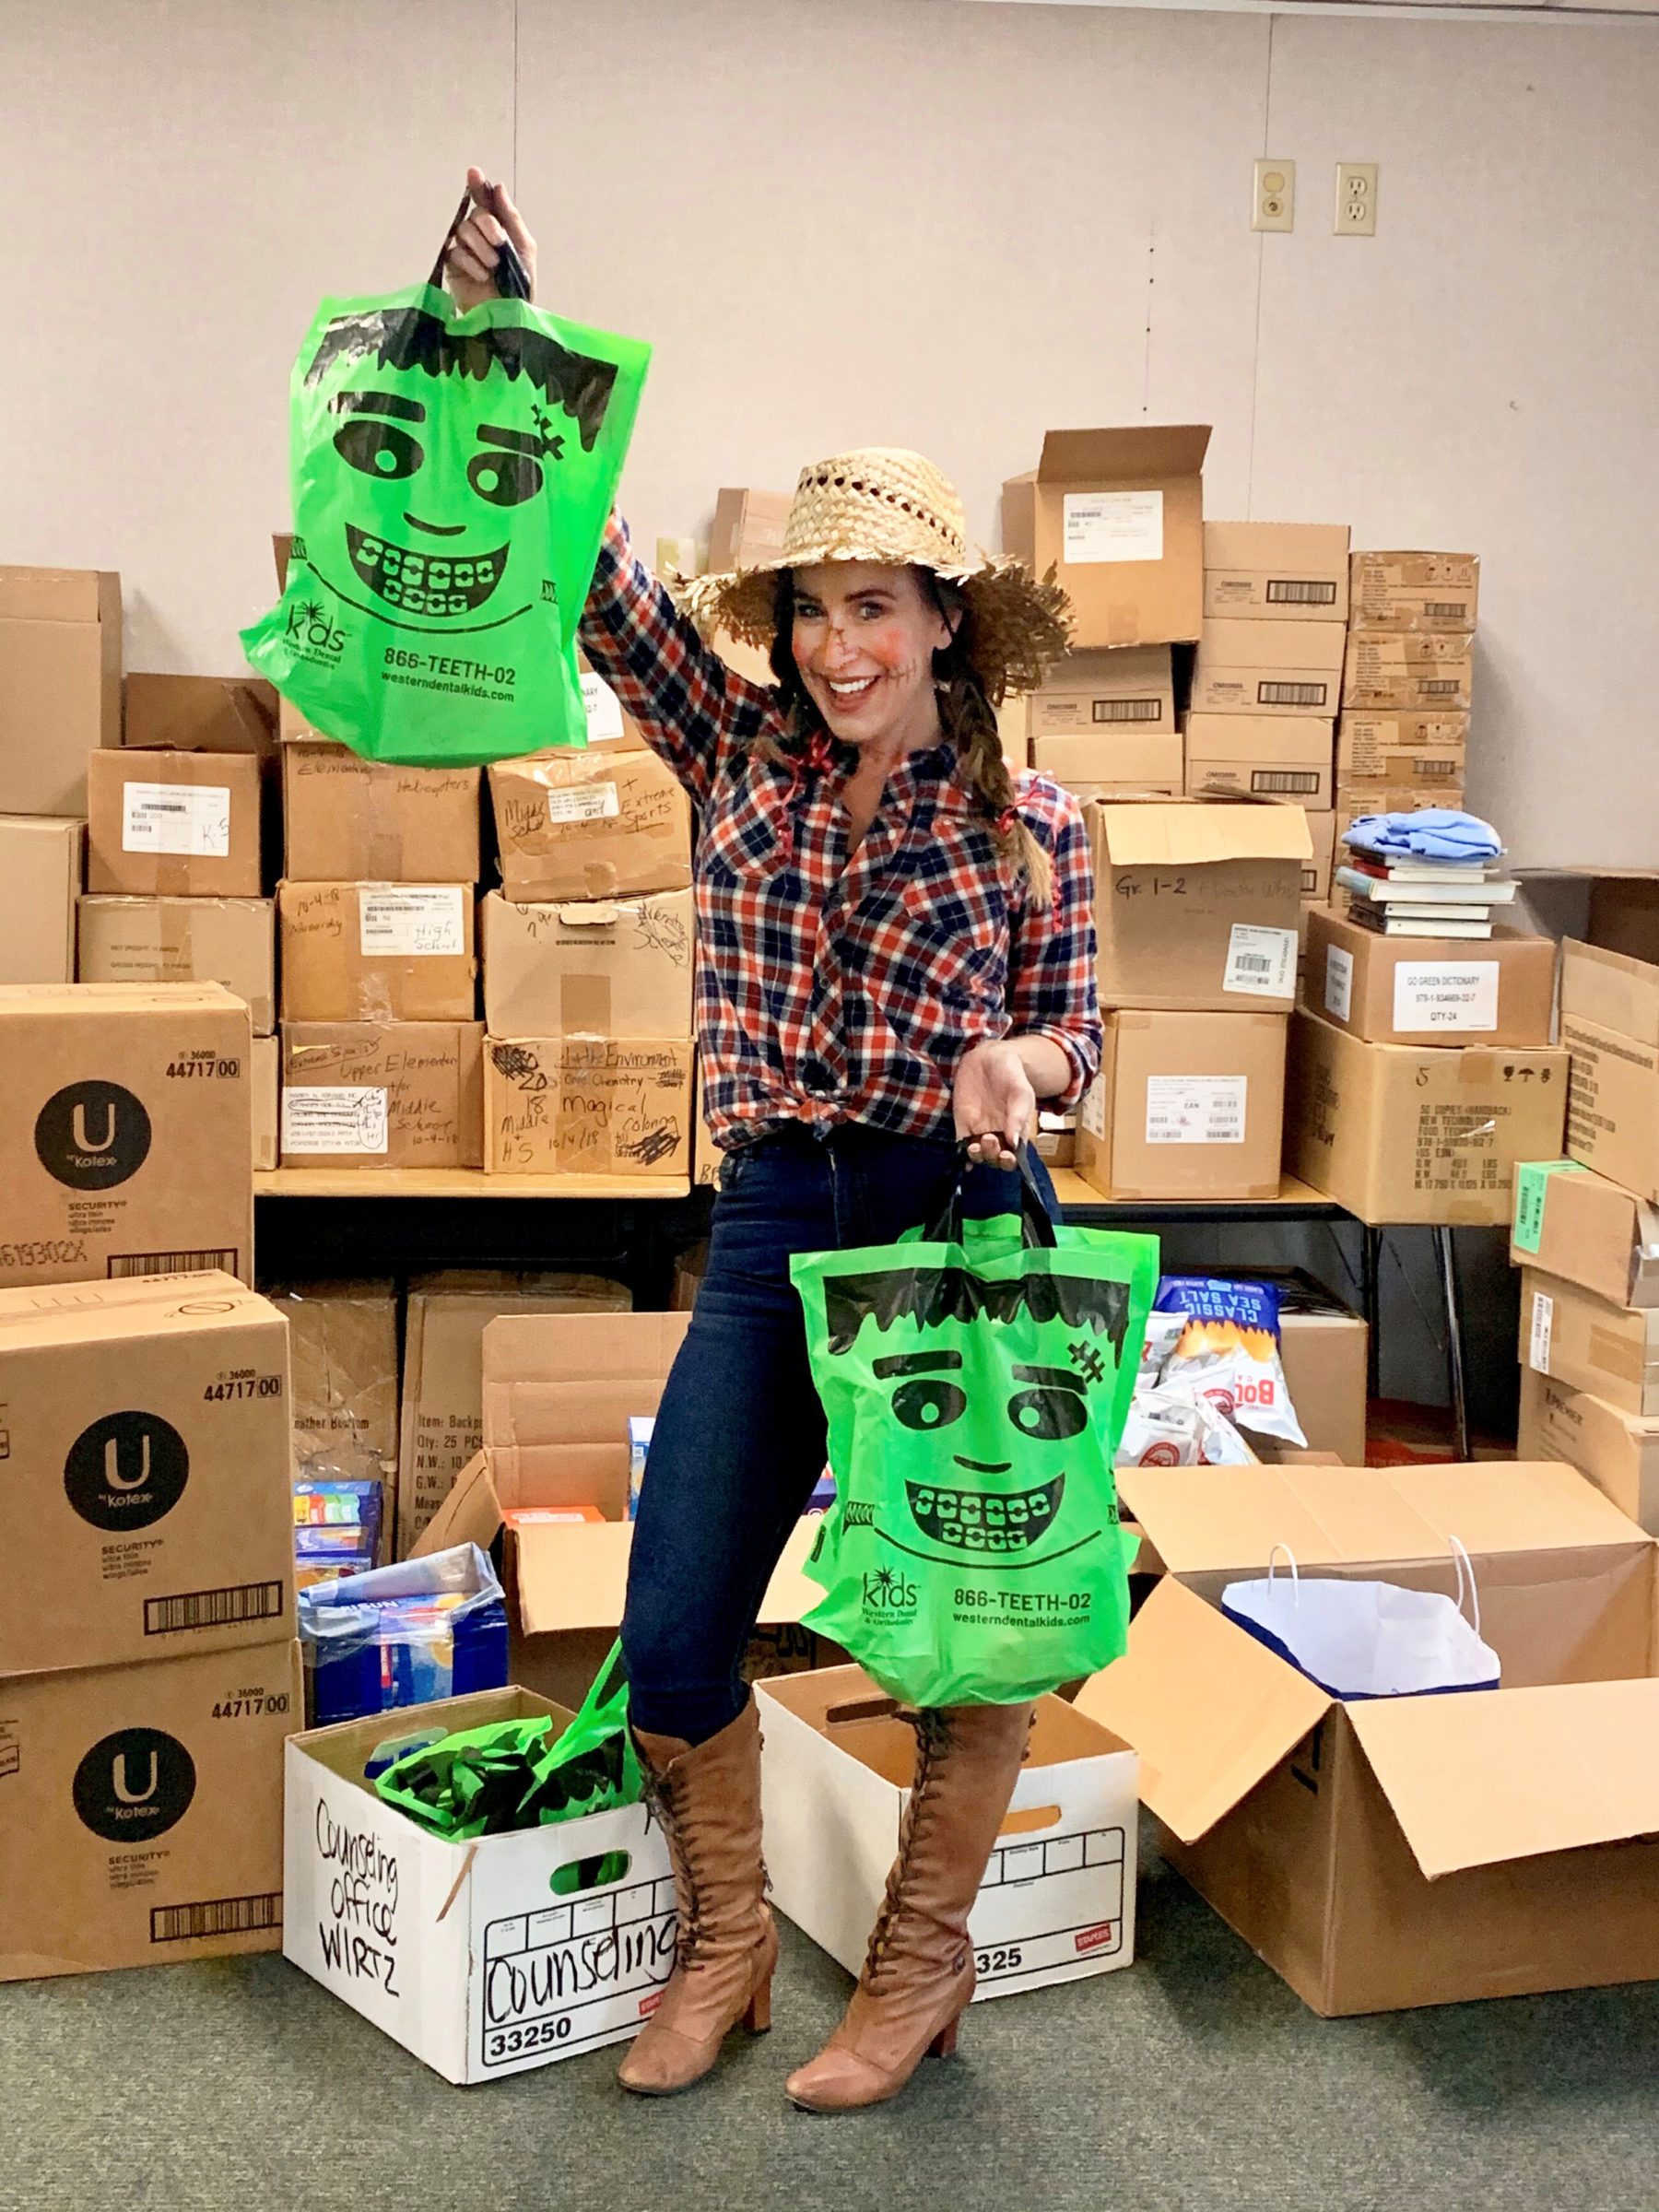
449;171;1100;2111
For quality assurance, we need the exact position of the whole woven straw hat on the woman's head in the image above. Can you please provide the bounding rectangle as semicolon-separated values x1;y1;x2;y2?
684;444;1071;703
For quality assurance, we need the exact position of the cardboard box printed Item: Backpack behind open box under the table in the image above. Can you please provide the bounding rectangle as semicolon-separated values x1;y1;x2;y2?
398;1267;637;1559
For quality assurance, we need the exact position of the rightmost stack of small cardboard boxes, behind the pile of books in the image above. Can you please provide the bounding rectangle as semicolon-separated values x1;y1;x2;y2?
1336;553;1480;836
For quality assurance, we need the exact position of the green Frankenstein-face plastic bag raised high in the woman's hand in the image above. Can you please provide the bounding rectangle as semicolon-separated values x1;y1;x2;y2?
241;286;651;768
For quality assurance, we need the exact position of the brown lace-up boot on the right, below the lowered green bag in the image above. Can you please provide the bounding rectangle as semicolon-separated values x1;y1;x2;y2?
785;1705;1033;2112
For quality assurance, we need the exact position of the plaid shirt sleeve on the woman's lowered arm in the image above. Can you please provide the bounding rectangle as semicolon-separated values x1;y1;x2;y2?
1008;776;1101;1111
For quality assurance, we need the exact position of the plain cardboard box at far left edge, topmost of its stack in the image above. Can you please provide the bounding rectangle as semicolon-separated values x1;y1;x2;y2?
0;569;122;814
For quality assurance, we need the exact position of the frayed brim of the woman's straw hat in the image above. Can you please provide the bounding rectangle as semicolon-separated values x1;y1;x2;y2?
677;547;1071;706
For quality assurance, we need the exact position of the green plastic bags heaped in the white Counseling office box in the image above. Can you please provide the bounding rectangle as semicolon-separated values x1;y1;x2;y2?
374;1643;643;1842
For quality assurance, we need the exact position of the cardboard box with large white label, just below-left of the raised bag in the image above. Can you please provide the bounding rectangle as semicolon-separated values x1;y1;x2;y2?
87;752;265;898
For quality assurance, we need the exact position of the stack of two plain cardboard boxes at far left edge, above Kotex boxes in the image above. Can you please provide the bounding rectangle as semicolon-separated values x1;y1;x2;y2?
0;569;122;984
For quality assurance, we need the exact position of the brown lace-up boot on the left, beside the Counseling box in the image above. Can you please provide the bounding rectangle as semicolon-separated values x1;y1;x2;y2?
618;1697;779;2097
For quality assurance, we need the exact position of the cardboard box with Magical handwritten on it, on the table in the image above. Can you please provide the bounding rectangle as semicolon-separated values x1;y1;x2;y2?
485;1038;695;1177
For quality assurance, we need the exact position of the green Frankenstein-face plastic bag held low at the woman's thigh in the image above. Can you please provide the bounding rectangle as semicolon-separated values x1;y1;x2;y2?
792;1194;1157;1705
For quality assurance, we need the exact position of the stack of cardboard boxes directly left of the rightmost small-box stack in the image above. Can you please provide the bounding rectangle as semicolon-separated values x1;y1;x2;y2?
1185;522;1347;940
